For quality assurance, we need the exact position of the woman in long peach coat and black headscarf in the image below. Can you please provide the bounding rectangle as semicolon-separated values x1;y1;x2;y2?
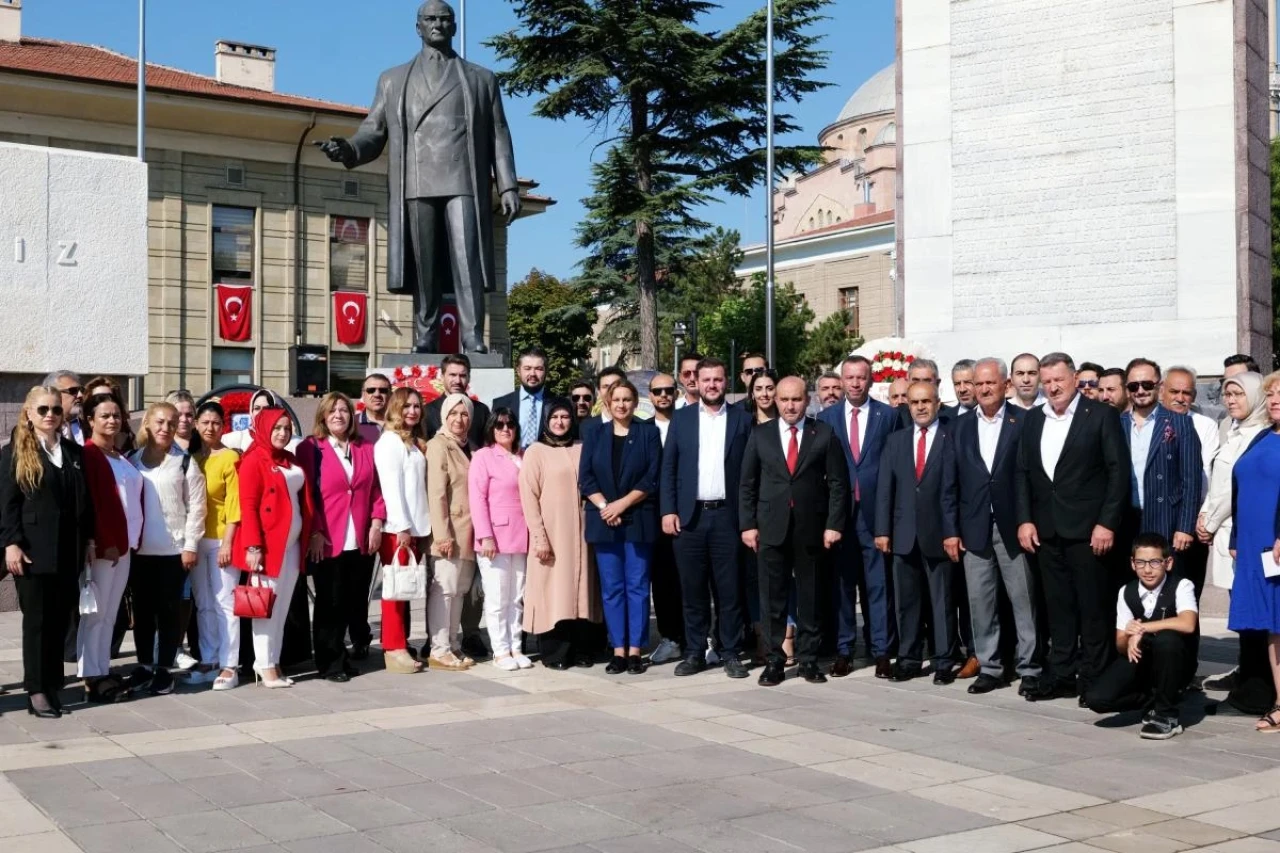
520;398;602;670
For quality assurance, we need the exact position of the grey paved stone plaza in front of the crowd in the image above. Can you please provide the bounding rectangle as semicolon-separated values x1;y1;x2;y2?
0;613;1280;853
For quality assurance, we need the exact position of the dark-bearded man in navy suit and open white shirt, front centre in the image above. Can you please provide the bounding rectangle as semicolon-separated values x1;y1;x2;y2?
659;359;751;679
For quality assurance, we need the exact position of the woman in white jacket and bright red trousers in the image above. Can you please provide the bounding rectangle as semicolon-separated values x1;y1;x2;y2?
374;388;431;672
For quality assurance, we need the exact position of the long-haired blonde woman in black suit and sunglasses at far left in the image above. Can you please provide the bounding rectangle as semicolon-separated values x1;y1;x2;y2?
0;386;95;719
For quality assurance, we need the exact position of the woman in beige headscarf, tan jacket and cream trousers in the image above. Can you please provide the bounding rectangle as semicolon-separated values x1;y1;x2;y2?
426;393;476;670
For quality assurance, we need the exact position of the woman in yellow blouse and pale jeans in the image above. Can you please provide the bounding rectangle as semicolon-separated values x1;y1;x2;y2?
191;401;241;690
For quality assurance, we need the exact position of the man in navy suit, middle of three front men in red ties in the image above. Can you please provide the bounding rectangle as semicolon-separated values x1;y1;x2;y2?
818;356;899;679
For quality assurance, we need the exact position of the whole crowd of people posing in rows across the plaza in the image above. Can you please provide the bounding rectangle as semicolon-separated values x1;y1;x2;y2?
0;350;1280;739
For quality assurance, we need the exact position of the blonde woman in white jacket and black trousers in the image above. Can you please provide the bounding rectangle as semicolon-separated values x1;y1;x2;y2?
129;402;206;693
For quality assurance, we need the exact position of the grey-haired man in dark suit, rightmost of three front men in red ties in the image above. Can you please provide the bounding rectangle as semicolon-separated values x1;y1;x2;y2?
874;382;960;684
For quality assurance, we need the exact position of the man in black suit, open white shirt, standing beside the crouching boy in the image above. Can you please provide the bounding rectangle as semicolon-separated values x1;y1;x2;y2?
1015;352;1129;702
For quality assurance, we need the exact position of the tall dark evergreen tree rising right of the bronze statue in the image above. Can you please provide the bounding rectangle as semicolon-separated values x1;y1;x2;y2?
490;0;828;368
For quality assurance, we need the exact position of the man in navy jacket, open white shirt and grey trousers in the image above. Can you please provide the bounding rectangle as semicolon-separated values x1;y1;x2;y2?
955;359;1041;694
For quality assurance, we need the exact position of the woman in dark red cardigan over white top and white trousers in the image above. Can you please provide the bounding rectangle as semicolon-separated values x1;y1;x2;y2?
77;393;142;702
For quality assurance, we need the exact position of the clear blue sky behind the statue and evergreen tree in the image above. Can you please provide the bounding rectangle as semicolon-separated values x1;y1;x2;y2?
23;0;893;282
